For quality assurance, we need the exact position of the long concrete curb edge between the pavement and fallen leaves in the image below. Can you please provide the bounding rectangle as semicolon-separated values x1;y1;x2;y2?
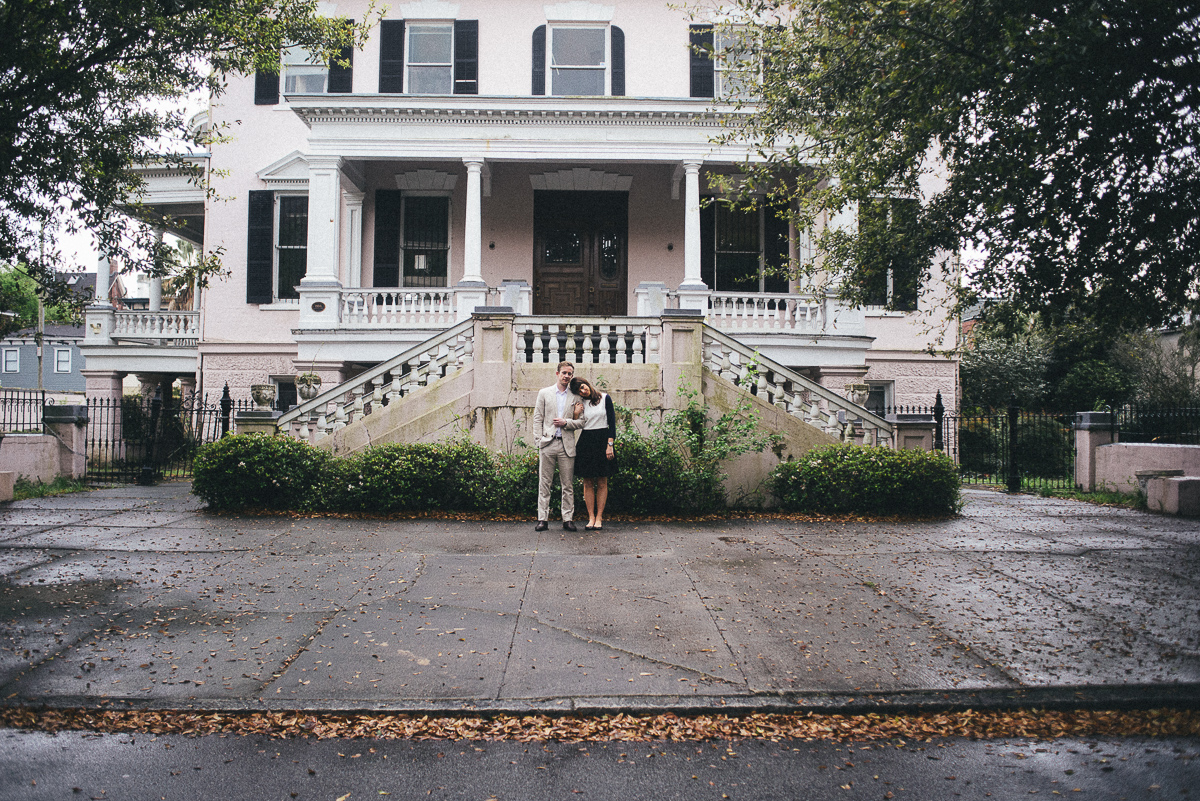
9;682;1200;717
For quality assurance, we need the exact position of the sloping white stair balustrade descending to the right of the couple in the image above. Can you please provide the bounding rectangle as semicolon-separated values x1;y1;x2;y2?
703;325;892;445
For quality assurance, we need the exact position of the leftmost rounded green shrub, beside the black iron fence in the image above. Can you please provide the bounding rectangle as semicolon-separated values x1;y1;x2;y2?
192;434;332;510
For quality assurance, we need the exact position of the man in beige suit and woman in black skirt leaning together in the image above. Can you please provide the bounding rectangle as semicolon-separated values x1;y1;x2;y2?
533;362;617;531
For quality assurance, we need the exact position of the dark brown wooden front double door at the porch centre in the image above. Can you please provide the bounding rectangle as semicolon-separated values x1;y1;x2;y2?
533;191;629;317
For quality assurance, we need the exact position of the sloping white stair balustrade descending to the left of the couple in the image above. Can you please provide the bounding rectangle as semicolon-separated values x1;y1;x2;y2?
278;319;475;441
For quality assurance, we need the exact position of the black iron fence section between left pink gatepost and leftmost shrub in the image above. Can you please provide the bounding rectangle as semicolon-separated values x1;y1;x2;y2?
84;393;254;484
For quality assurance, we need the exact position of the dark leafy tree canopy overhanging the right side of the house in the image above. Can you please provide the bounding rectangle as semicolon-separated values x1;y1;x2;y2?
710;0;1200;325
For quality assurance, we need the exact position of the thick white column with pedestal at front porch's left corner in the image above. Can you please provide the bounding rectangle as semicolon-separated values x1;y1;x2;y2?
298;156;342;329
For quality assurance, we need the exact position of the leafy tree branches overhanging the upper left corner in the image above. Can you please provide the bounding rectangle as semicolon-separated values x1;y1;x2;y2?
0;0;366;299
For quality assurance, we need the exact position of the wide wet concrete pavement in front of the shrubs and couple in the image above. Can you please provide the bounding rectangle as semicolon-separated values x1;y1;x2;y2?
0;483;1200;712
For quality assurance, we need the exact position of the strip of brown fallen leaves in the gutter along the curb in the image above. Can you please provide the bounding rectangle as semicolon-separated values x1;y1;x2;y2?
0;707;1200;745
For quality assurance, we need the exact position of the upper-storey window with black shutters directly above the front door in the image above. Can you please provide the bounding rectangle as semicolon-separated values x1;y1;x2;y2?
533;23;625;97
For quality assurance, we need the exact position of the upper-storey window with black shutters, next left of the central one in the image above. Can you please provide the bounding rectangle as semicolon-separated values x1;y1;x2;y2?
379;19;479;95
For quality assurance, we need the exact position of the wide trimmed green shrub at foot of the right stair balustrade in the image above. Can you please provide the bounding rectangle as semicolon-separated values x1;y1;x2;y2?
770;445;962;516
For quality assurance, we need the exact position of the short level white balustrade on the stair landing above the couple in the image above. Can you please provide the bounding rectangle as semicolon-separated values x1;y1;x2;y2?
512;315;662;365
